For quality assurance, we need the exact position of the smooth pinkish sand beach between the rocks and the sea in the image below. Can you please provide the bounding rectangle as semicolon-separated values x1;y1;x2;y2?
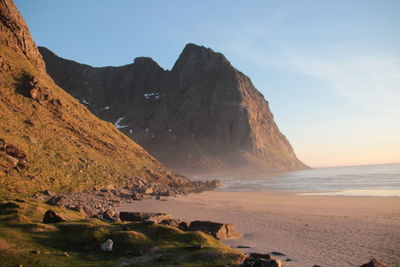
119;191;400;267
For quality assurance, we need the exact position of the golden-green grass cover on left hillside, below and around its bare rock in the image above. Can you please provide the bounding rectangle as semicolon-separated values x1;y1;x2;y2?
0;44;183;199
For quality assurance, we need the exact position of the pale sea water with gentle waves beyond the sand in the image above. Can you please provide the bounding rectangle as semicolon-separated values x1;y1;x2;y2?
220;164;400;197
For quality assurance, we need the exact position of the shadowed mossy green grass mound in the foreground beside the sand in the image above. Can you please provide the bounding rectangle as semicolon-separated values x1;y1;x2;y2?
0;201;243;266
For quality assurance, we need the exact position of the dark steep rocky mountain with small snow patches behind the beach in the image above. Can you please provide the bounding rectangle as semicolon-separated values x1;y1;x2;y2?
39;44;307;173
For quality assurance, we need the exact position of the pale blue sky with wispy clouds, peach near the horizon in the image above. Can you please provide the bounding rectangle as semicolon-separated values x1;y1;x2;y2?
15;0;400;167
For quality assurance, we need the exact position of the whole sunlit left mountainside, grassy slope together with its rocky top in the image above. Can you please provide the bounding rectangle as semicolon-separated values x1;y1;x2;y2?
0;0;202;194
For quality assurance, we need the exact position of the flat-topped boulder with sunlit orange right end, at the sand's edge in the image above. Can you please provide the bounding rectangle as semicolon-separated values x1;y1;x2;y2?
188;221;243;240
